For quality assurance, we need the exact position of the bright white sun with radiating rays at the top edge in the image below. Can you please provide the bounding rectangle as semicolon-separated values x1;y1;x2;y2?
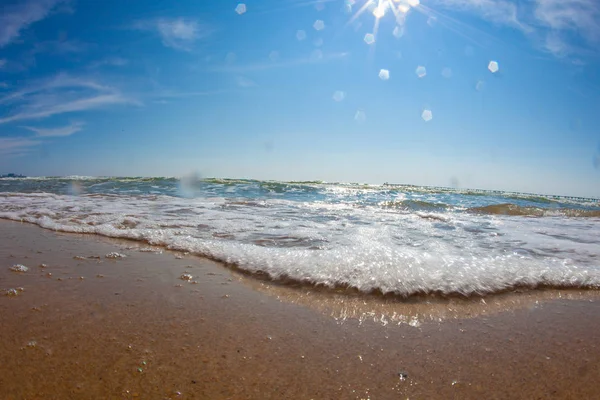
347;0;420;44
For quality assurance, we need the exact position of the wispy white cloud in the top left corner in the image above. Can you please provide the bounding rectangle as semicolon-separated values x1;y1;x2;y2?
0;0;65;48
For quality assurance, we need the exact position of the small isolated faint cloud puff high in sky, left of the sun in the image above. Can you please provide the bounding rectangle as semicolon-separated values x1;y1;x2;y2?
133;18;212;51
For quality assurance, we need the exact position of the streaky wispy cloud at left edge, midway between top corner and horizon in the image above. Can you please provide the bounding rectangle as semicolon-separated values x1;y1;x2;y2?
0;74;139;124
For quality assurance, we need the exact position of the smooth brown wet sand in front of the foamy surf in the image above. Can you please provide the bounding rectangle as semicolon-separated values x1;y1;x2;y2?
0;221;600;399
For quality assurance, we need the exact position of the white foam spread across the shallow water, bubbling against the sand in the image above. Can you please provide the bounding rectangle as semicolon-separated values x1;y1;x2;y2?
0;194;600;295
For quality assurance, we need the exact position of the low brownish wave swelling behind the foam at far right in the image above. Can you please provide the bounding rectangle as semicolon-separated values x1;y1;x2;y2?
466;203;600;218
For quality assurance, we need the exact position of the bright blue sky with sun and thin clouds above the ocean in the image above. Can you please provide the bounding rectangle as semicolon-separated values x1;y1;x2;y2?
0;0;600;197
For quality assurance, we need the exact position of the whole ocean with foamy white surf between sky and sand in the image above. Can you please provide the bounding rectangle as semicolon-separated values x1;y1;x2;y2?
0;177;600;297
